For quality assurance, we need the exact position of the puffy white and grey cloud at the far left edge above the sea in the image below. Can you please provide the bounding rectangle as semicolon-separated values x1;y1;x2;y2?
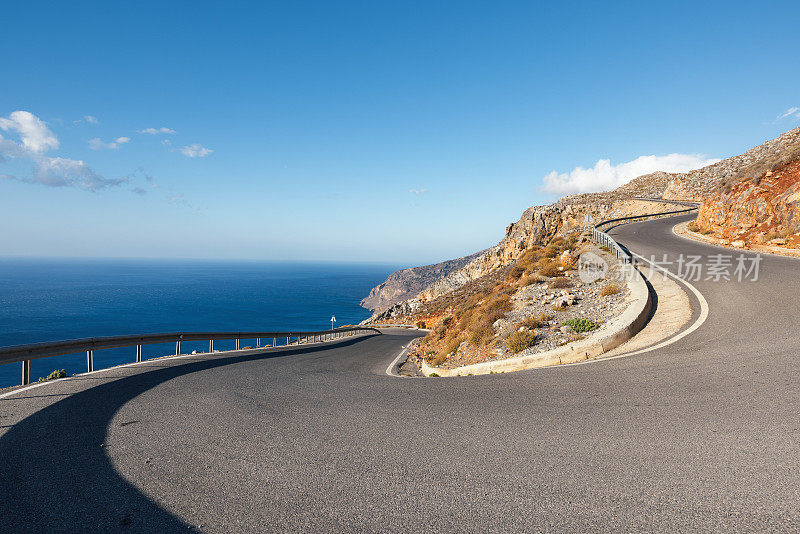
0;111;127;191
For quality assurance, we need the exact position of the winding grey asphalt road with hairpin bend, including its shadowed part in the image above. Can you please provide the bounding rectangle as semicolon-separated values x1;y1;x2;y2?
0;219;800;532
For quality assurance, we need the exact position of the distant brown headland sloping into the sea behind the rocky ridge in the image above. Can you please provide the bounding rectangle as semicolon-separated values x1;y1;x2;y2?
361;252;482;313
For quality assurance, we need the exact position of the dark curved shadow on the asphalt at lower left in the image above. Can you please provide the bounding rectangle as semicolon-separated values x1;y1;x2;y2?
0;336;373;532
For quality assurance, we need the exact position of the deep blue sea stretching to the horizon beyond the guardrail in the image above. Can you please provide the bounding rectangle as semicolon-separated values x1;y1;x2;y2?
0;259;399;387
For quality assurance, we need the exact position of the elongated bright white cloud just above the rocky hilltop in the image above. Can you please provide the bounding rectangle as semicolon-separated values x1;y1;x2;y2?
543;154;720;195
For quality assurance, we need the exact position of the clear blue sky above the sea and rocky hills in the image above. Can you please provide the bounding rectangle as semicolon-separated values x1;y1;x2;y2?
0;2;800;265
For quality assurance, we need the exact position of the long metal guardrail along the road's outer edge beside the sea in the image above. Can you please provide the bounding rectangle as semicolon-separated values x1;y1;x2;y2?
0;326;381;385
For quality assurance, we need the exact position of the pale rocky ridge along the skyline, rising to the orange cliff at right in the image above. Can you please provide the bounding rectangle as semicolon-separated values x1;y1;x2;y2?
368;128;800;322
